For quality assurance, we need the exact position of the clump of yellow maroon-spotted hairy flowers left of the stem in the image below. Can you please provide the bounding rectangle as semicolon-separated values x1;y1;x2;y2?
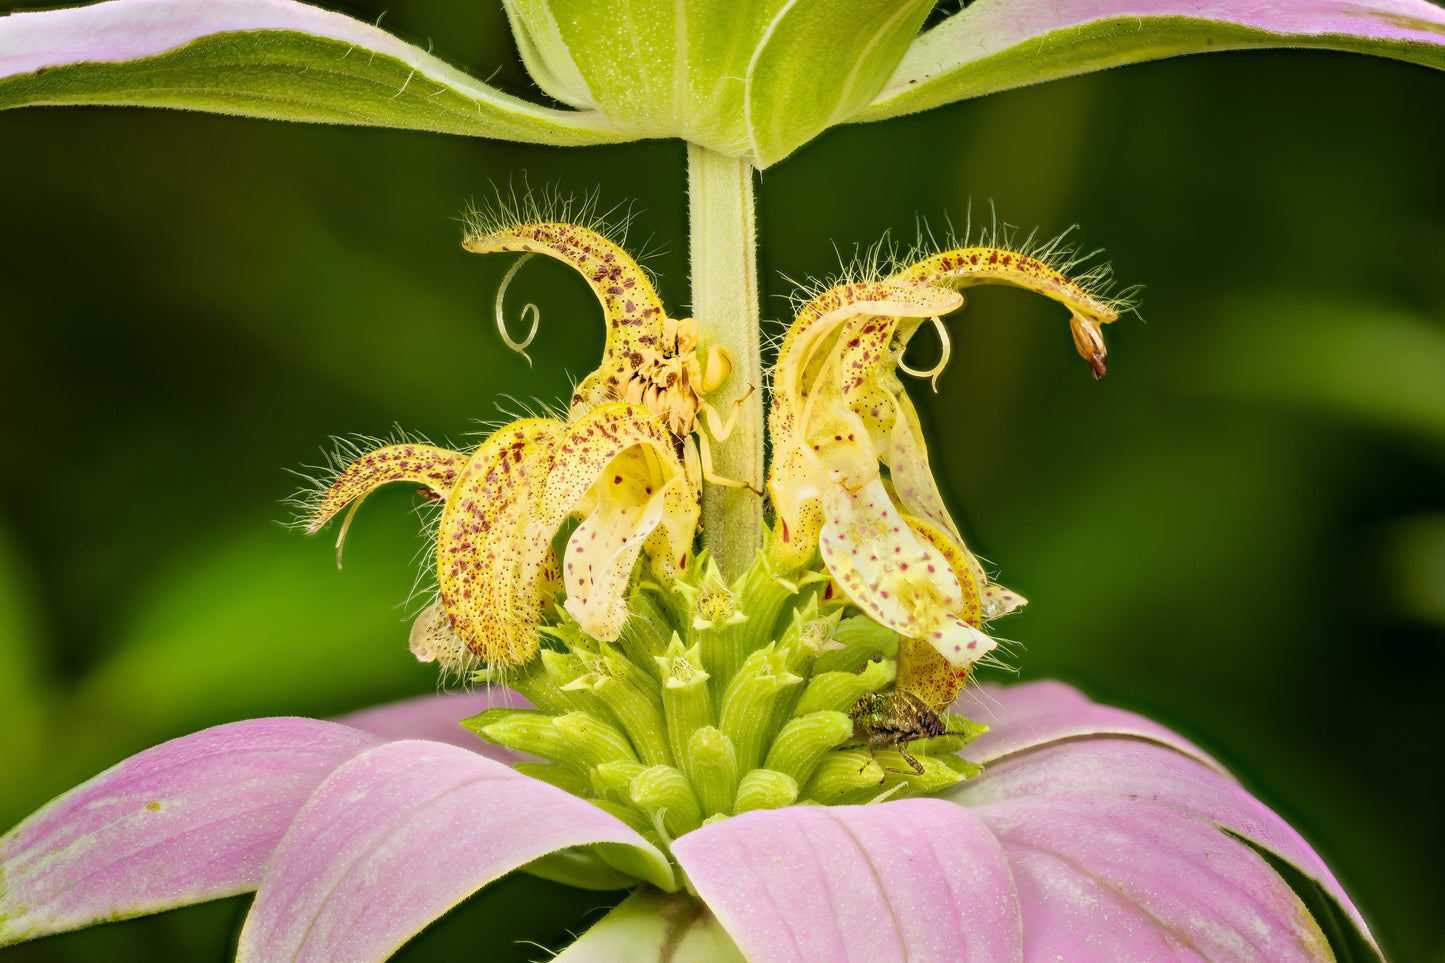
308;221;728;669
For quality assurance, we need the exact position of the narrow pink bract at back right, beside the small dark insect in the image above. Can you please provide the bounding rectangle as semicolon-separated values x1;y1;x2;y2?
954;680;1225;772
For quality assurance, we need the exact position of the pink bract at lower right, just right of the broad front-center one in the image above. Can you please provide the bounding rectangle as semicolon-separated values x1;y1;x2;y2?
974;792;1331;963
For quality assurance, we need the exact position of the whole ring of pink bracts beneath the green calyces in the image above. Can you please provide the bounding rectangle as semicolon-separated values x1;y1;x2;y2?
0;682;1374;963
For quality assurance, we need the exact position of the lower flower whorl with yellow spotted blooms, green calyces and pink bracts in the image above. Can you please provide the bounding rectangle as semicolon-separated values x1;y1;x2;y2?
0;221;1368;960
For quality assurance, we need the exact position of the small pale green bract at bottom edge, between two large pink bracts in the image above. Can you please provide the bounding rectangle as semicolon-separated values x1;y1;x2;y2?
552;886;747;963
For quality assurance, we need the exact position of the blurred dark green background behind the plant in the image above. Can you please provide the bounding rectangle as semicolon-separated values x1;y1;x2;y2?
0;0;1445;963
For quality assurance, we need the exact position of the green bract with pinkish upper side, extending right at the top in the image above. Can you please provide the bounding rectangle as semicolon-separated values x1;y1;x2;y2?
853;0;1445;121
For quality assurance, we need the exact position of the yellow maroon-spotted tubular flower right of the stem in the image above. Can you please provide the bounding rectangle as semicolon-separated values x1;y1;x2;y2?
769;238;1118;670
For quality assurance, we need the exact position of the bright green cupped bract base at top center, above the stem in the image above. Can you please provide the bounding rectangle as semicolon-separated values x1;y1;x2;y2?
507;0;932;166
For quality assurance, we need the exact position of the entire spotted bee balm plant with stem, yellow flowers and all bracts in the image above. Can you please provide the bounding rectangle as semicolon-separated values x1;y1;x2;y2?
0;0;1445;963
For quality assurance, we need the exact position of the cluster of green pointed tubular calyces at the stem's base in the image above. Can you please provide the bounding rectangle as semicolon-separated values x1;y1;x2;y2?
462;543;987;849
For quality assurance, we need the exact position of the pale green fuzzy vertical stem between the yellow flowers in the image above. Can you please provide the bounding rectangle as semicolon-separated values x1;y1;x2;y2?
688;145;763;581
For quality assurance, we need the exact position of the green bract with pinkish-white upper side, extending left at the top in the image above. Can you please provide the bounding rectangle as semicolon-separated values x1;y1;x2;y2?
0;0;627;145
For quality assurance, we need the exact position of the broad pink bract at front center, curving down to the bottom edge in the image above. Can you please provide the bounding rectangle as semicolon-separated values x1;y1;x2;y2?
672;800;1023;963
